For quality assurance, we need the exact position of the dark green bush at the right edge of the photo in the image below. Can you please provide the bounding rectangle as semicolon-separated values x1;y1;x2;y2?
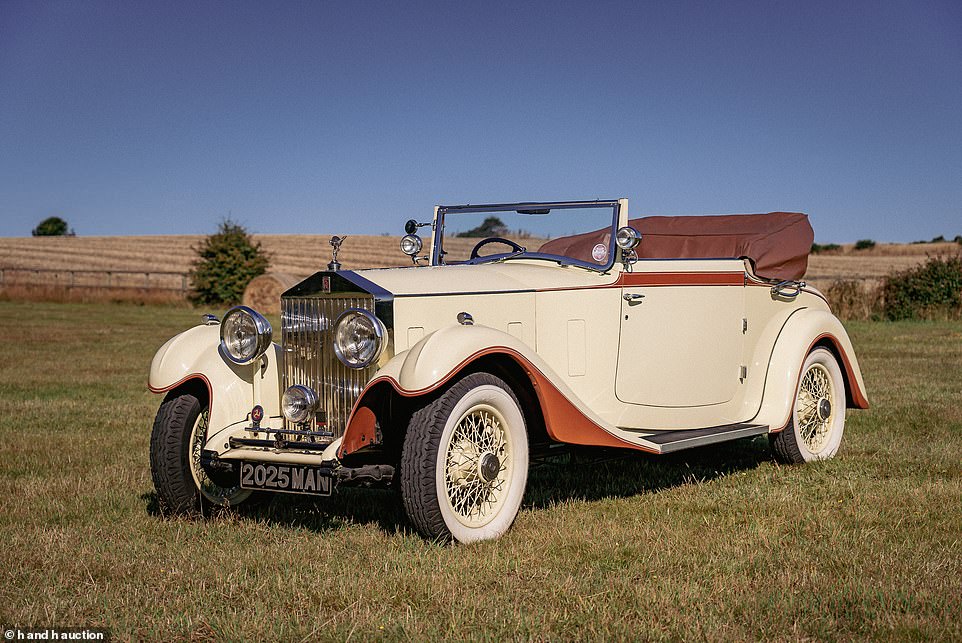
882;255;962;321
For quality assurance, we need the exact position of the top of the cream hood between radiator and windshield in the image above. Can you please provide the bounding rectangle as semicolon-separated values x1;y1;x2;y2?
356;259;616;297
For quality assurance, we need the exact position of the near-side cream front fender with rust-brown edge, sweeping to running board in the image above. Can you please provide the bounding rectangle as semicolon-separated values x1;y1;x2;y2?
338;326;641;457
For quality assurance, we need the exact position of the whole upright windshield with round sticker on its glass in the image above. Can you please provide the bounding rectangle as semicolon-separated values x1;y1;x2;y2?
435;201;618;270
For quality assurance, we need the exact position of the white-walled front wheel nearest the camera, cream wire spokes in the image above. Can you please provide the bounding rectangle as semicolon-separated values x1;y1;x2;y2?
401;373;528;542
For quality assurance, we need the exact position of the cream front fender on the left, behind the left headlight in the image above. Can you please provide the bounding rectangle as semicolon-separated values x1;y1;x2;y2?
147;325;281;451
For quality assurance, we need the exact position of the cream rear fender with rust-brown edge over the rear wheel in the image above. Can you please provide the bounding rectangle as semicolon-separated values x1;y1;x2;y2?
753;308;868;431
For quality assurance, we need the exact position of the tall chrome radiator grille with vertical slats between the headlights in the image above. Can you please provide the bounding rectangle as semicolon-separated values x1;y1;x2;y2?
281;294;377;440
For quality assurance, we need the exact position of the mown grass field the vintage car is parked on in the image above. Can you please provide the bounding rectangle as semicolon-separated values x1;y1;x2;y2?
0;302;962;640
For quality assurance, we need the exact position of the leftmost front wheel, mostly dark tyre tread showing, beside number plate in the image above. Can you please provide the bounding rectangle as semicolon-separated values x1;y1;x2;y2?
150;394;251;514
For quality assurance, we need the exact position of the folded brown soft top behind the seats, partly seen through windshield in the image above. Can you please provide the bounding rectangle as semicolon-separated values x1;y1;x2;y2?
539;212;815;279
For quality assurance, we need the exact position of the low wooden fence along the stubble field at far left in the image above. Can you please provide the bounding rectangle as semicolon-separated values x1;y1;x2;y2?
0;267;190;297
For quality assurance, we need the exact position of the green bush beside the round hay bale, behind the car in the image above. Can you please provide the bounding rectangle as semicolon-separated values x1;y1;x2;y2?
190;219;270;304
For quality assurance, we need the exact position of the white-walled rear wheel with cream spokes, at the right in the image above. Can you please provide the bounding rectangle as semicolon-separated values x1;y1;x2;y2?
770;348;845;464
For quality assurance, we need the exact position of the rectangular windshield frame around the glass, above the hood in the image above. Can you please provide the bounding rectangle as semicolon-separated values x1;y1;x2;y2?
431;199;621;272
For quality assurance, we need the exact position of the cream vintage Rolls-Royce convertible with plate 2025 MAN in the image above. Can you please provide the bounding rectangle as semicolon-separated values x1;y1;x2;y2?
149;199;868;542
